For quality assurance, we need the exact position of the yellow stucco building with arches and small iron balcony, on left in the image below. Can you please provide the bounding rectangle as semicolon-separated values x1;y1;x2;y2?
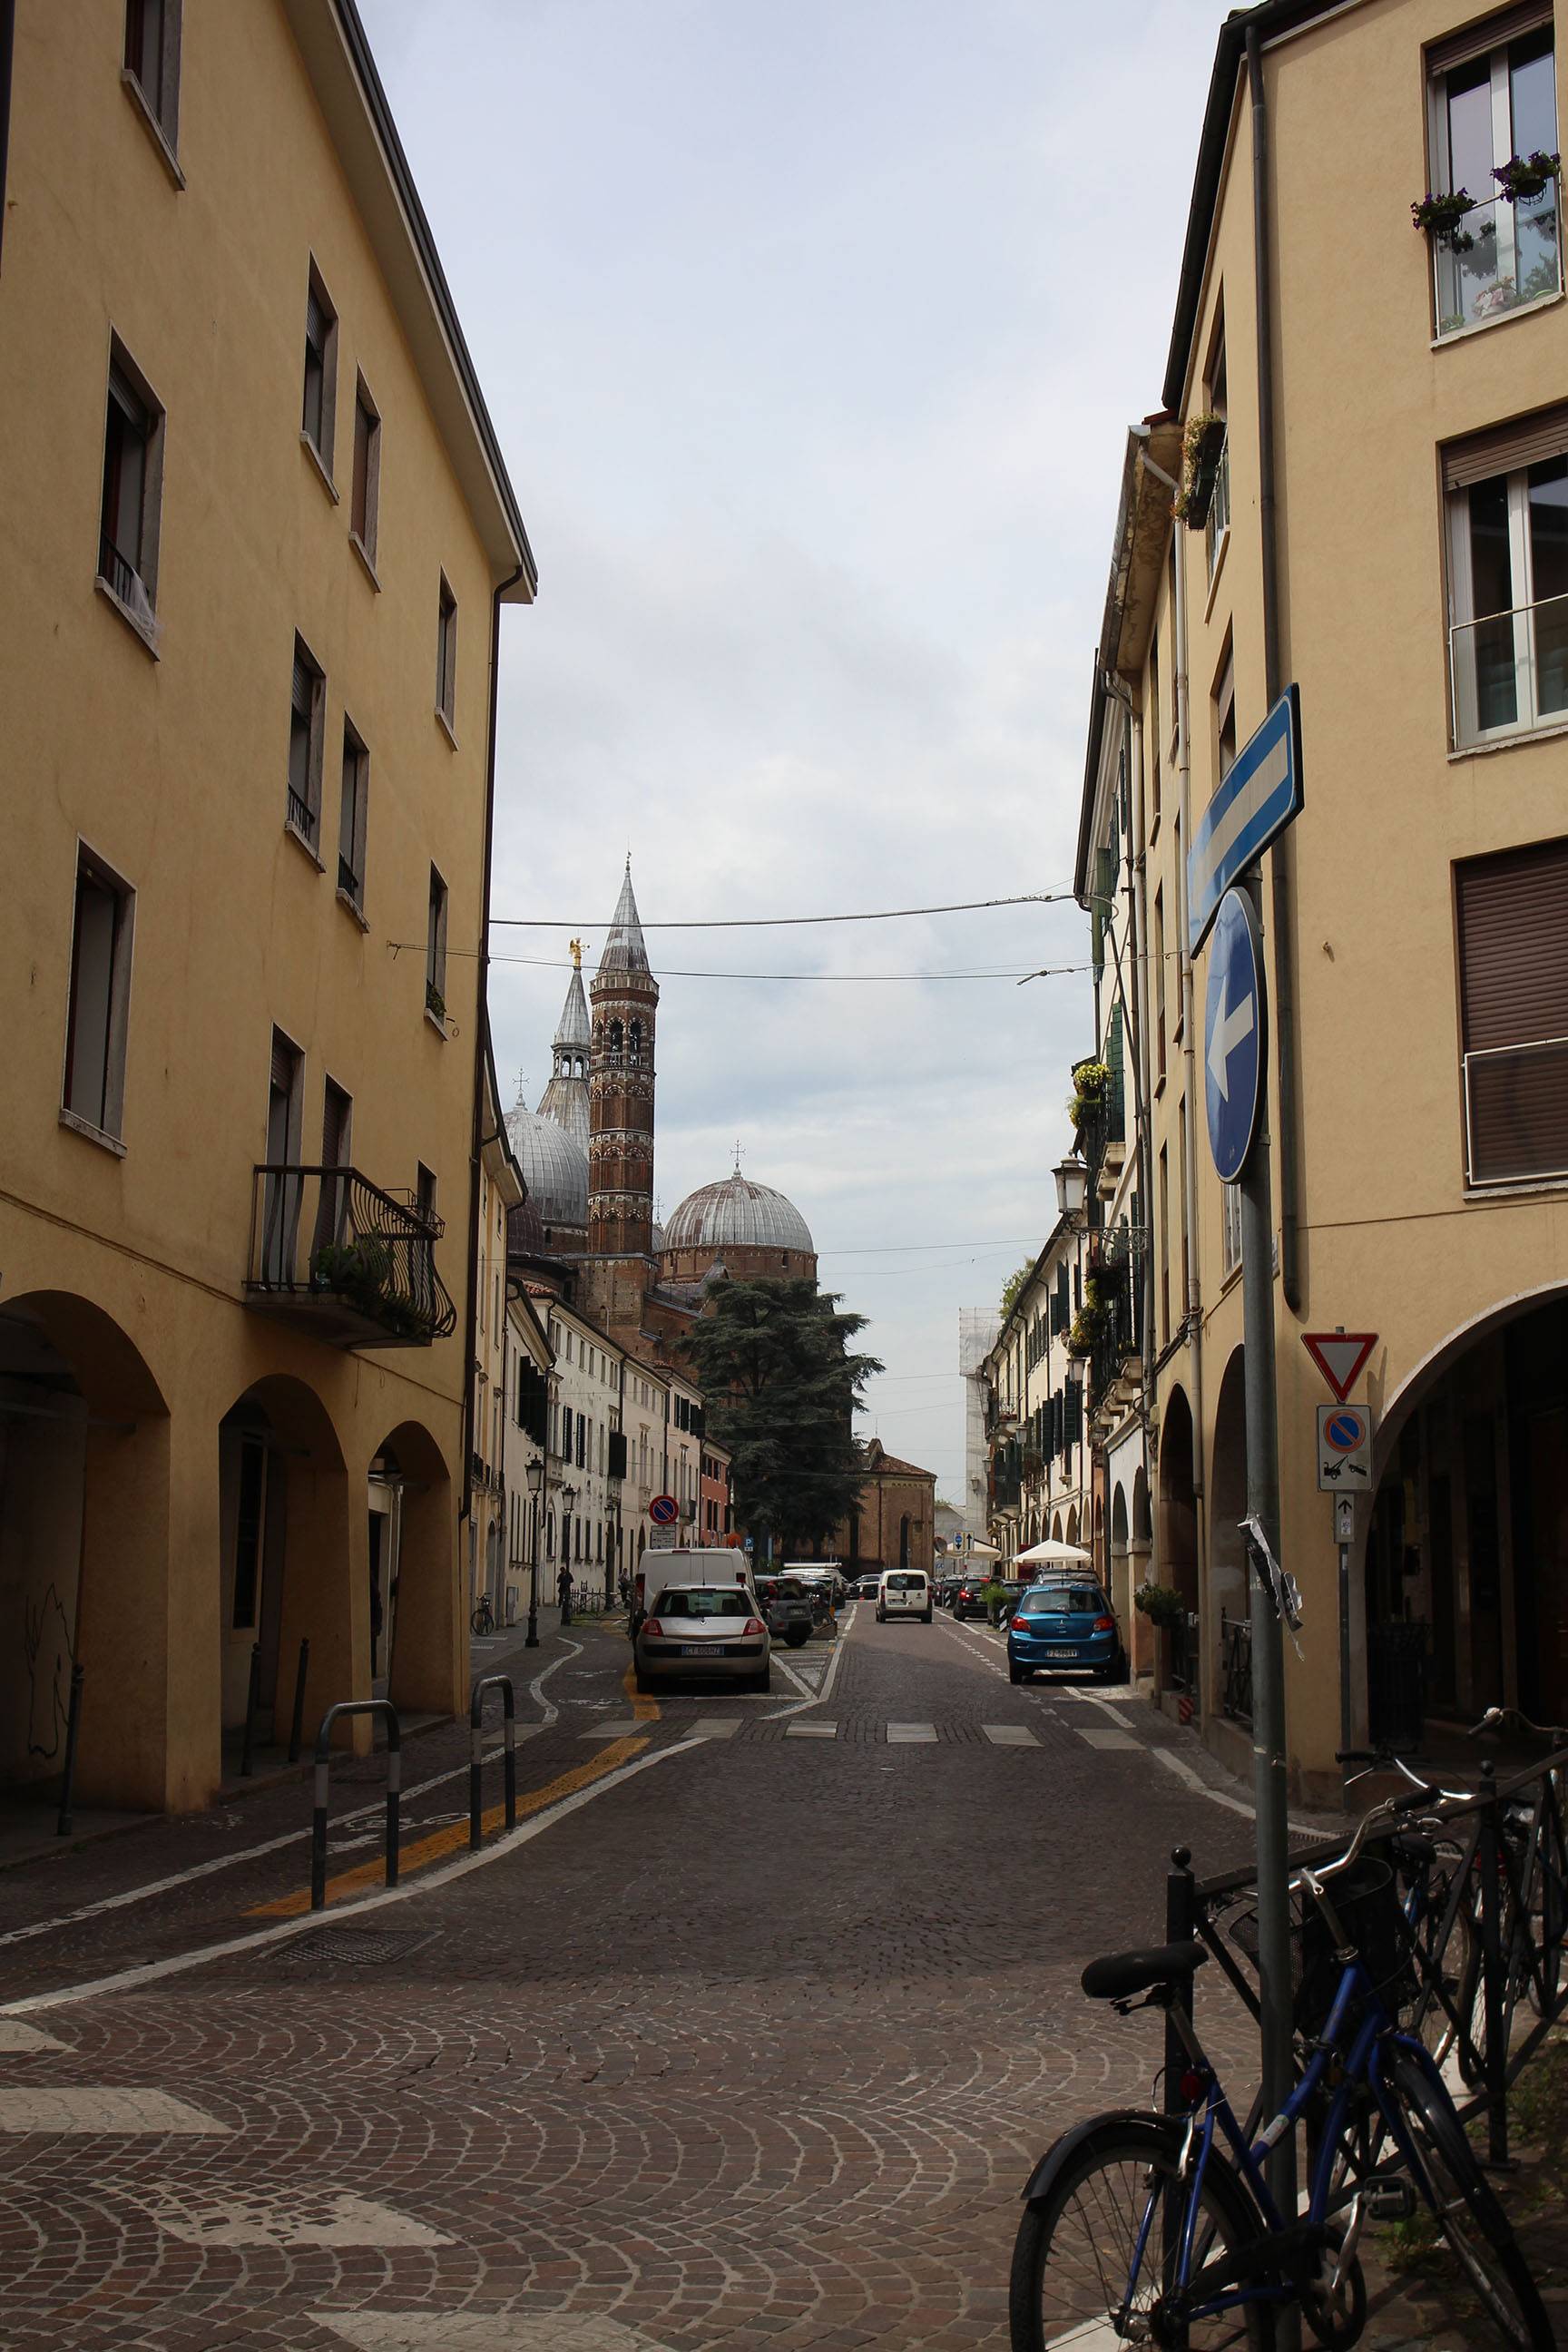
0;0;534;1807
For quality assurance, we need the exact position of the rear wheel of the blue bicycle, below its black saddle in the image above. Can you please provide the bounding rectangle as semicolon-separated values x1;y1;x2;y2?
1008;2114;1272;2352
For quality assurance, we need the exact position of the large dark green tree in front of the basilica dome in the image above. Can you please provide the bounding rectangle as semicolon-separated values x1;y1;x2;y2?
686;1277;882;1557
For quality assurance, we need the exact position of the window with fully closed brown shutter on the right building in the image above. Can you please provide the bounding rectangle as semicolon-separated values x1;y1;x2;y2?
1455;839;1568;1185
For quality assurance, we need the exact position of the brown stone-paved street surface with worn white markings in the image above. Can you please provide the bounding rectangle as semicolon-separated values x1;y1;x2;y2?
0;1613;1551;2352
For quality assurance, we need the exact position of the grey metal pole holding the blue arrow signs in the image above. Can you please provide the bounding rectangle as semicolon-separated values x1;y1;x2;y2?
1239;866;1295;2213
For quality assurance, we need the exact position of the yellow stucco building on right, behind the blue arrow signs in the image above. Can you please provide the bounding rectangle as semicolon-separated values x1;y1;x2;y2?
1079;0;1568;1792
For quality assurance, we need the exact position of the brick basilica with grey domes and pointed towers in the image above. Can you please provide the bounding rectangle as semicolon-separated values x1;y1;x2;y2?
505;858;816;1357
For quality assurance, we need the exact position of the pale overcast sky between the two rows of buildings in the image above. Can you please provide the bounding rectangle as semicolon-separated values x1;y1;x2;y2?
359;0;1220;1501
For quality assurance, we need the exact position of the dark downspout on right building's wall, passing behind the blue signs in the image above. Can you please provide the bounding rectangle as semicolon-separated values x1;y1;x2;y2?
1246;24;1302;1315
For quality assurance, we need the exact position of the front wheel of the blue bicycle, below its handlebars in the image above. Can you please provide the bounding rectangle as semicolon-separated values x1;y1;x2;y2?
1389;2051;1556;2352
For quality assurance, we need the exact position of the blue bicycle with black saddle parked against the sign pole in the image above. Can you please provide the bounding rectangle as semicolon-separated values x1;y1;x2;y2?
1008;1790;1553;2352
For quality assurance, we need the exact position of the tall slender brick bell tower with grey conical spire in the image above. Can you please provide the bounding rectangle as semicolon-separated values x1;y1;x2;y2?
583;856;658;1331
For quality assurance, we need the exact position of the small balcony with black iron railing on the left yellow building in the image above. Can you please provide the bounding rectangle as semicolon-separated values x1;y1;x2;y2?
244;1161;458;1348
